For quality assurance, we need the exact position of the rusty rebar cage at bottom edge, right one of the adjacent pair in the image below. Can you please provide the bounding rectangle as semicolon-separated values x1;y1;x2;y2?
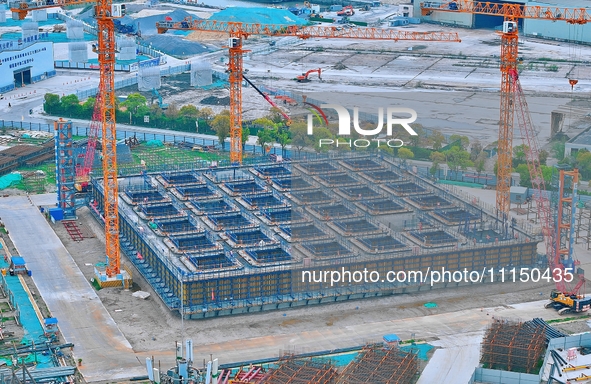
337;344;419;384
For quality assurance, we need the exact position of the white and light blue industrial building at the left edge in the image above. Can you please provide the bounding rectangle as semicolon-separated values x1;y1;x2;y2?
0;35;56;93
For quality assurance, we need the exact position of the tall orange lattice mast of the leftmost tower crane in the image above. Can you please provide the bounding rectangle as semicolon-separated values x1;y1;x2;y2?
95;0;120;278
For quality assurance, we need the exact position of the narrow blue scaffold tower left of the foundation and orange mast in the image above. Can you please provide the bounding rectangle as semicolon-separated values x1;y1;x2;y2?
54;119;76;219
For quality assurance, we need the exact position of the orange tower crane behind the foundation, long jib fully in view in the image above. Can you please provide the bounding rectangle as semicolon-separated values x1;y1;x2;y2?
156;17;460;164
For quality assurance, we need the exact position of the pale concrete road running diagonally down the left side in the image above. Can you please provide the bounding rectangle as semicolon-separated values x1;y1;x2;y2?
0;194;146;382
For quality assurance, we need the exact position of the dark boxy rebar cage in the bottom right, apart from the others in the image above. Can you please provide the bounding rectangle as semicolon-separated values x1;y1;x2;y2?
480;319;546;374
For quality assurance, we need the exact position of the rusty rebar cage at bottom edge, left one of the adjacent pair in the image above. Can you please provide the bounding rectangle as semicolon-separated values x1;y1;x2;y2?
260;355;338;384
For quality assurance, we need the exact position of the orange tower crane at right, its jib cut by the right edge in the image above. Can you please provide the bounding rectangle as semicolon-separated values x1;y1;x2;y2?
420;0;591;218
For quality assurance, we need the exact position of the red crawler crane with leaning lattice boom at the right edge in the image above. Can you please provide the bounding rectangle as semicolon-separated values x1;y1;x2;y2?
508;69;591;315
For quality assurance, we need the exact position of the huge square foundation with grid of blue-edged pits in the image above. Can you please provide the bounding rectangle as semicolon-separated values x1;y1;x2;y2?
93;154;539;318
